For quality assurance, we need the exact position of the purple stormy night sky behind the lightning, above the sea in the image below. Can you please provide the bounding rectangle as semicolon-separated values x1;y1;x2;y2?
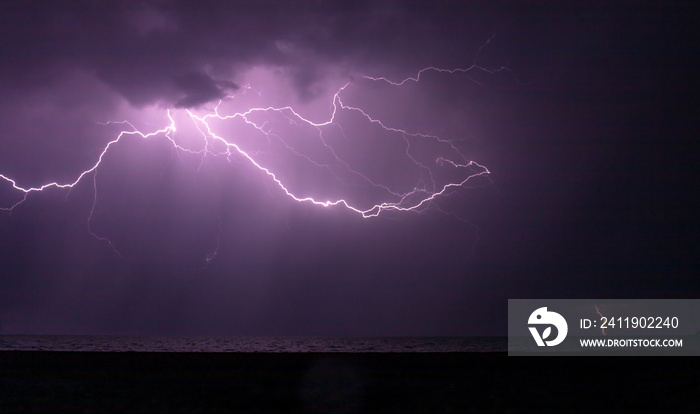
0;0;700;336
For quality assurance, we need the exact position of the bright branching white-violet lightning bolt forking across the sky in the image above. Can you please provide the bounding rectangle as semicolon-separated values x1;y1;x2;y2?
0;66;498;263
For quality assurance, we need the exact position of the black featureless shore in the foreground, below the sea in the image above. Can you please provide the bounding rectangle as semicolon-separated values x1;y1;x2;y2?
0;351;700;413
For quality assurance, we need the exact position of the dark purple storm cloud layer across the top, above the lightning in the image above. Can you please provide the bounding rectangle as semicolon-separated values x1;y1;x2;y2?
0;1;508;106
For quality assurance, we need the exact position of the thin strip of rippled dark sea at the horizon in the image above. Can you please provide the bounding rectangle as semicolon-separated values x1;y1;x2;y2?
0;335;508;352
